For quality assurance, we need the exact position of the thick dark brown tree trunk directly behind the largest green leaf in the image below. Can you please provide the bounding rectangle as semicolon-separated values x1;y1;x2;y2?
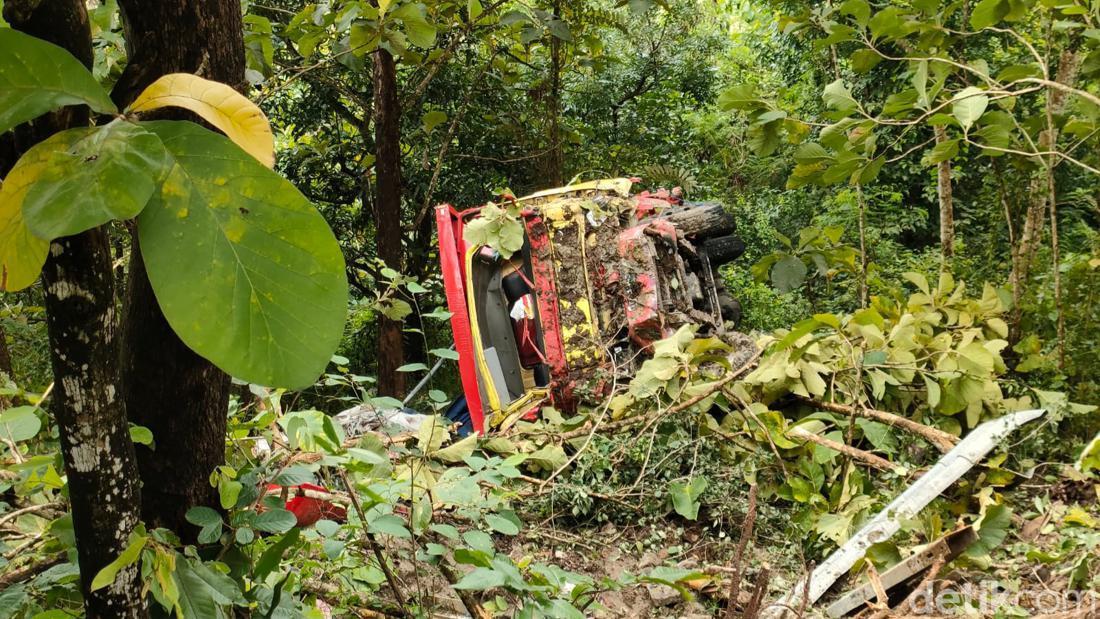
111;0;244;541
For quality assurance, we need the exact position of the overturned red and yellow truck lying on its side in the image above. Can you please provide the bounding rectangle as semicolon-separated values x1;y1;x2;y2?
436;179;745;433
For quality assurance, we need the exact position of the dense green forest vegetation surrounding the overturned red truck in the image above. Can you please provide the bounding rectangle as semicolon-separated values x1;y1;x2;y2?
0;0;1100;619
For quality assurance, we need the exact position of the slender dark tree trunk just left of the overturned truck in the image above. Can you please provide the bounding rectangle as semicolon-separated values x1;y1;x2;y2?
374;48;405;398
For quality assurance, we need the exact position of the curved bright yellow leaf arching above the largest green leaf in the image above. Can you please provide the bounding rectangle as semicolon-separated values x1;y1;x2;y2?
128;73;275;167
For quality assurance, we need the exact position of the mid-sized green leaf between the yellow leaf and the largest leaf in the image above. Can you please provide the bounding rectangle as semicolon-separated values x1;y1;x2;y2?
23;120;168;240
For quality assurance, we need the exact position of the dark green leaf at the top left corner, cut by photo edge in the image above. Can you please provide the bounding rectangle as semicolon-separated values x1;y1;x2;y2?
0;27;118;133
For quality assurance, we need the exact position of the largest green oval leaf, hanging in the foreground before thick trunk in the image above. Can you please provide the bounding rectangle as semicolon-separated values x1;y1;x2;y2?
138;121;348;388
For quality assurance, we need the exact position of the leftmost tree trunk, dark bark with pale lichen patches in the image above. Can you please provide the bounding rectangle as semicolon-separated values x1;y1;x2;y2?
0;0;147;619
